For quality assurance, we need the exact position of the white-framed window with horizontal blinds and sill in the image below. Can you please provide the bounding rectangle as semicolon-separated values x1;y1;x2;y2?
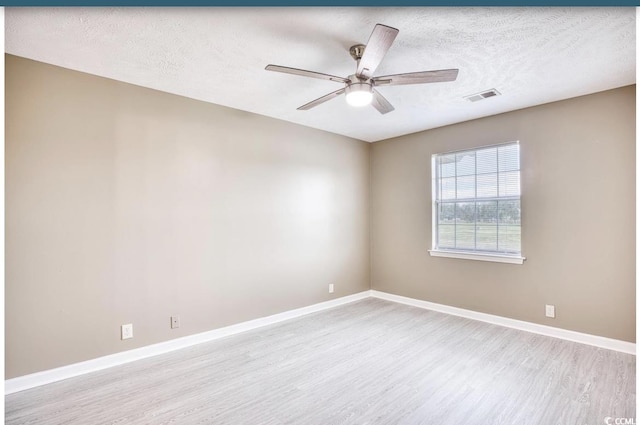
430;142;524;264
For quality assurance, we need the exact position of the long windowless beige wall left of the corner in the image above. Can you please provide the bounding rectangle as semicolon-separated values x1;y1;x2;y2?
5;56;370;378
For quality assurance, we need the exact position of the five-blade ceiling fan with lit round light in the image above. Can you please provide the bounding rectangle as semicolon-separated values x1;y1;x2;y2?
265;24;458;114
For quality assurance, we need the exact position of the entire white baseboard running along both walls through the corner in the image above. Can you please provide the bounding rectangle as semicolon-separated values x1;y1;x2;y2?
4;290;636;394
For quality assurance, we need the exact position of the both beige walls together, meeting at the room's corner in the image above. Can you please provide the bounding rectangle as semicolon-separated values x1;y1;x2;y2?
5;55;635;378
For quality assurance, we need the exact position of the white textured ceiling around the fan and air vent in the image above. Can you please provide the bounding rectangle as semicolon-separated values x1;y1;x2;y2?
5;8;636;141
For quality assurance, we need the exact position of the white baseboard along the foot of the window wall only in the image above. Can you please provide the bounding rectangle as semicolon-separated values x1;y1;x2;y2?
371;290;636;355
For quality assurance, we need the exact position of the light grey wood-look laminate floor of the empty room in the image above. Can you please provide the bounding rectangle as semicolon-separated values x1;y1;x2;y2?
5;299;636;425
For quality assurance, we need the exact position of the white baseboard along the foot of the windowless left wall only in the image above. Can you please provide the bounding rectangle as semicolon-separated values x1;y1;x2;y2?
4;290;371;394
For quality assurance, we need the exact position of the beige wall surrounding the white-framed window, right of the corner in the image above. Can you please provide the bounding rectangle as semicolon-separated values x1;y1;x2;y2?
371;86;635;341
